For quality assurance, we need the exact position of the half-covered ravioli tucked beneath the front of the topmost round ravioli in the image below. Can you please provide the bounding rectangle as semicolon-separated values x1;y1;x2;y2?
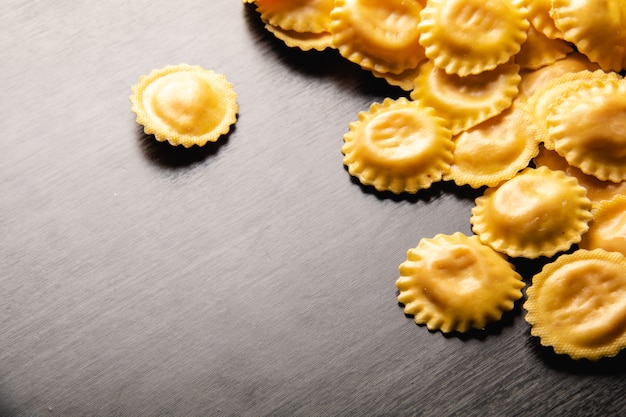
411;60;521;135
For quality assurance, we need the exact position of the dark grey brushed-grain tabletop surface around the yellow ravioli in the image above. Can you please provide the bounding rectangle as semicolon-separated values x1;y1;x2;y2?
0;0;626;417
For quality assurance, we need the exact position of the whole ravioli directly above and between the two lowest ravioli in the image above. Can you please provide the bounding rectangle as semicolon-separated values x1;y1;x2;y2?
470;167;591;259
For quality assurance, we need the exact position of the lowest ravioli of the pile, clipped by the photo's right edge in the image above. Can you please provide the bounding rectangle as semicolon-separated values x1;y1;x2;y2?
524;249;626;361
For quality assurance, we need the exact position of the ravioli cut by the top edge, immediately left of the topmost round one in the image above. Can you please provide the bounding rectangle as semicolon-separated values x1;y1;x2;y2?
330;0;425;74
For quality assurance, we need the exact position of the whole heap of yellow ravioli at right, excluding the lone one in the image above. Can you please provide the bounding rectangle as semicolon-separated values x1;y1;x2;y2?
244;0;626;361
